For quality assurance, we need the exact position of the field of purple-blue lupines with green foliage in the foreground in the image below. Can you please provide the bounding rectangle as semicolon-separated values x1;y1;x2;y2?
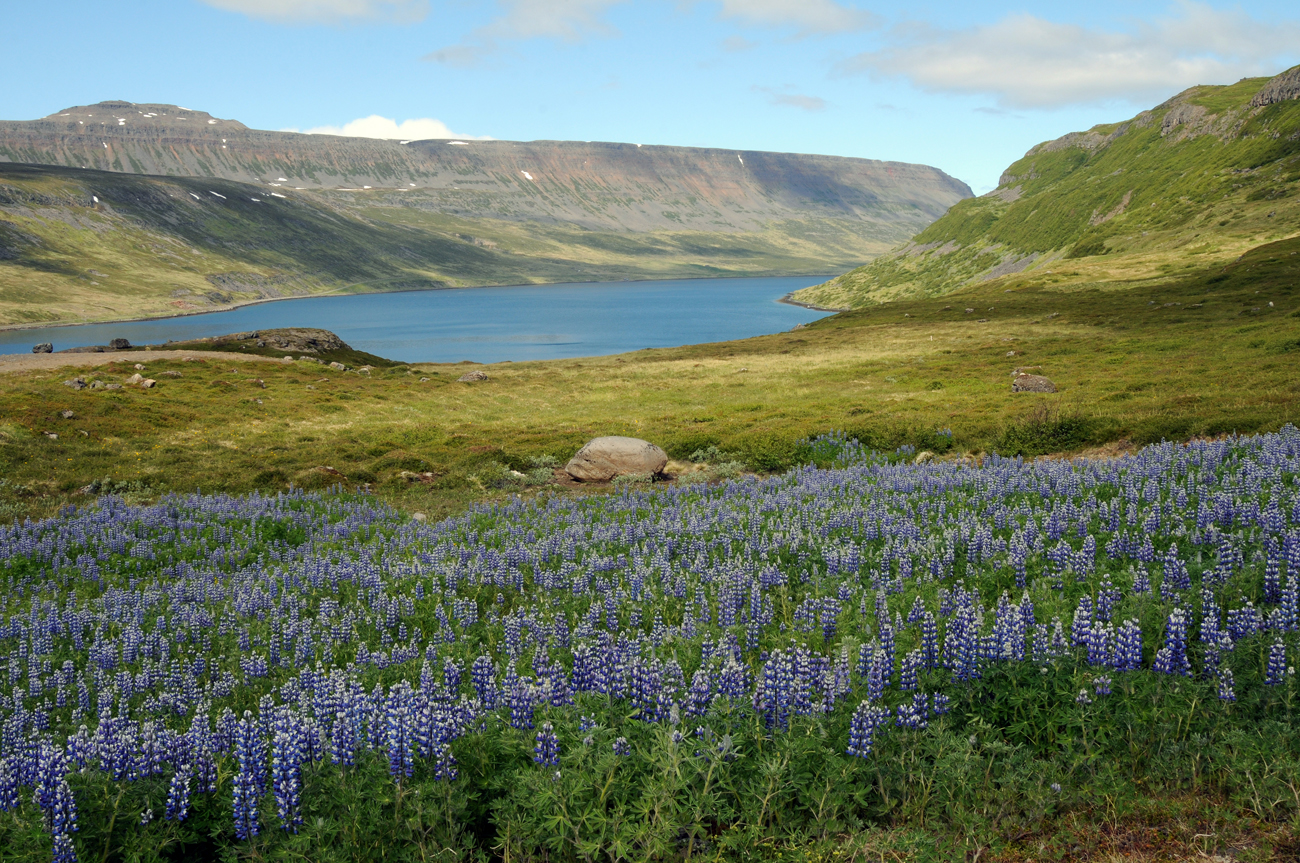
0;426;1300;863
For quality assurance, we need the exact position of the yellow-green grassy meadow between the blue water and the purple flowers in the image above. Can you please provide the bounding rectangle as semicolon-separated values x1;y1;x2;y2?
0;228;1300;516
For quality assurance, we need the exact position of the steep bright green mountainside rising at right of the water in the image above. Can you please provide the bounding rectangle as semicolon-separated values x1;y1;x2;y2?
796;66;1300;308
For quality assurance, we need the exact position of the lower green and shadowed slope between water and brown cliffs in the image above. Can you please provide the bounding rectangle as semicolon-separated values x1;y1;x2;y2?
0;164;887;325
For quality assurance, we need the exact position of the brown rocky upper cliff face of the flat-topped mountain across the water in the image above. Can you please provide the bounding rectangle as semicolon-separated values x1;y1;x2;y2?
0;101;971;233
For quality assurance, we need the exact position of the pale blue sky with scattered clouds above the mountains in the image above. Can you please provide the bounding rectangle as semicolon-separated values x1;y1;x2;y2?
0;0;1300;194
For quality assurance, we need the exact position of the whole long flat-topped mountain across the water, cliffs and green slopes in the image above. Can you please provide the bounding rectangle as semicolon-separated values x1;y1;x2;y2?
0;101;971;325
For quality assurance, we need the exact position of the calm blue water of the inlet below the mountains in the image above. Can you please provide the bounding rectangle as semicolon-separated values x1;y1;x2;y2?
0;276;826;363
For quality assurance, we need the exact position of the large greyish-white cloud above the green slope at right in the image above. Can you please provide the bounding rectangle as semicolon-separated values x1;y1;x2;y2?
841;3;1300;108
